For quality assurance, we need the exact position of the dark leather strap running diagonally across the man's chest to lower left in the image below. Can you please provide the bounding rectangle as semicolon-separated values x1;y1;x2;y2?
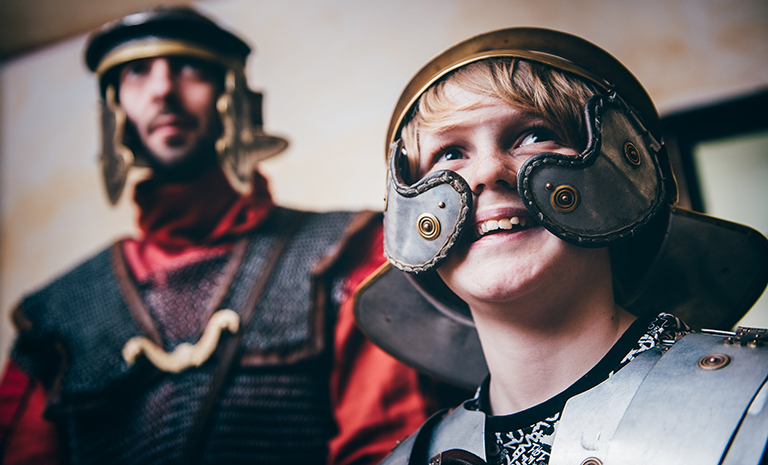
182;211;306;465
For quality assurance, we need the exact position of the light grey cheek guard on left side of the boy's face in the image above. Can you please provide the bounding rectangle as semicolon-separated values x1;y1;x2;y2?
384;140;472;274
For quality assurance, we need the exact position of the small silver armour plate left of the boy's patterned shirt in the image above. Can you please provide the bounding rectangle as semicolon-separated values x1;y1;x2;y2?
381;401;485;465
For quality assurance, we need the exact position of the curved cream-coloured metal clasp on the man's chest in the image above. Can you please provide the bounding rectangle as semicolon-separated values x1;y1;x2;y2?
123;309;240;373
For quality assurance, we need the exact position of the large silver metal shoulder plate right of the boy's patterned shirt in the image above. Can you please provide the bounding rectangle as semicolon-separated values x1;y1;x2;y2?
549;333;768;465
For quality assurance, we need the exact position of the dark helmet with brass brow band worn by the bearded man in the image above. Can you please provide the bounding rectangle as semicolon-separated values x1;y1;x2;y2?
85;7;288;204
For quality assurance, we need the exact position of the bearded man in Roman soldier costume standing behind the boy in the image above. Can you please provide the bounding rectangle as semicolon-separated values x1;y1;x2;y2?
0;8;460;464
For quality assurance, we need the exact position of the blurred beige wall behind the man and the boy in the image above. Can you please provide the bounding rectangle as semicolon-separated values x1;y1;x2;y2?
0;0;768;366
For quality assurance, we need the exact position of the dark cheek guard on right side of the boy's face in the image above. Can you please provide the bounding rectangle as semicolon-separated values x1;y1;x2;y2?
517;95;666;247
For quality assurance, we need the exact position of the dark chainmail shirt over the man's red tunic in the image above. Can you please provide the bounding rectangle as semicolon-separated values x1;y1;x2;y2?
13;207;354;465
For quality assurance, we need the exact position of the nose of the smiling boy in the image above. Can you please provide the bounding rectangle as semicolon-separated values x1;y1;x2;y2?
465;148;520;195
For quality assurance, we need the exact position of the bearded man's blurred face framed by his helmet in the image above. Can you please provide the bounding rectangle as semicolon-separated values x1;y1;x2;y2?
119;57;221;170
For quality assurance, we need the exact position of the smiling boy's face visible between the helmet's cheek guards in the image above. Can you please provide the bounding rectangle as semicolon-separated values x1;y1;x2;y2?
418;85;608;309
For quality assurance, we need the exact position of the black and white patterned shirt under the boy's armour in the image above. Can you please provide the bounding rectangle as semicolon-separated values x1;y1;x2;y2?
469;313;691;465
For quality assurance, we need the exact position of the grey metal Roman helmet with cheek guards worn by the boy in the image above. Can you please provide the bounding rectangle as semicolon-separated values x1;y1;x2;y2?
355;28;768;388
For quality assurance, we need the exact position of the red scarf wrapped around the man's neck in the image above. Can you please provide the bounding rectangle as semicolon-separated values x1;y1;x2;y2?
122;167;273;281
